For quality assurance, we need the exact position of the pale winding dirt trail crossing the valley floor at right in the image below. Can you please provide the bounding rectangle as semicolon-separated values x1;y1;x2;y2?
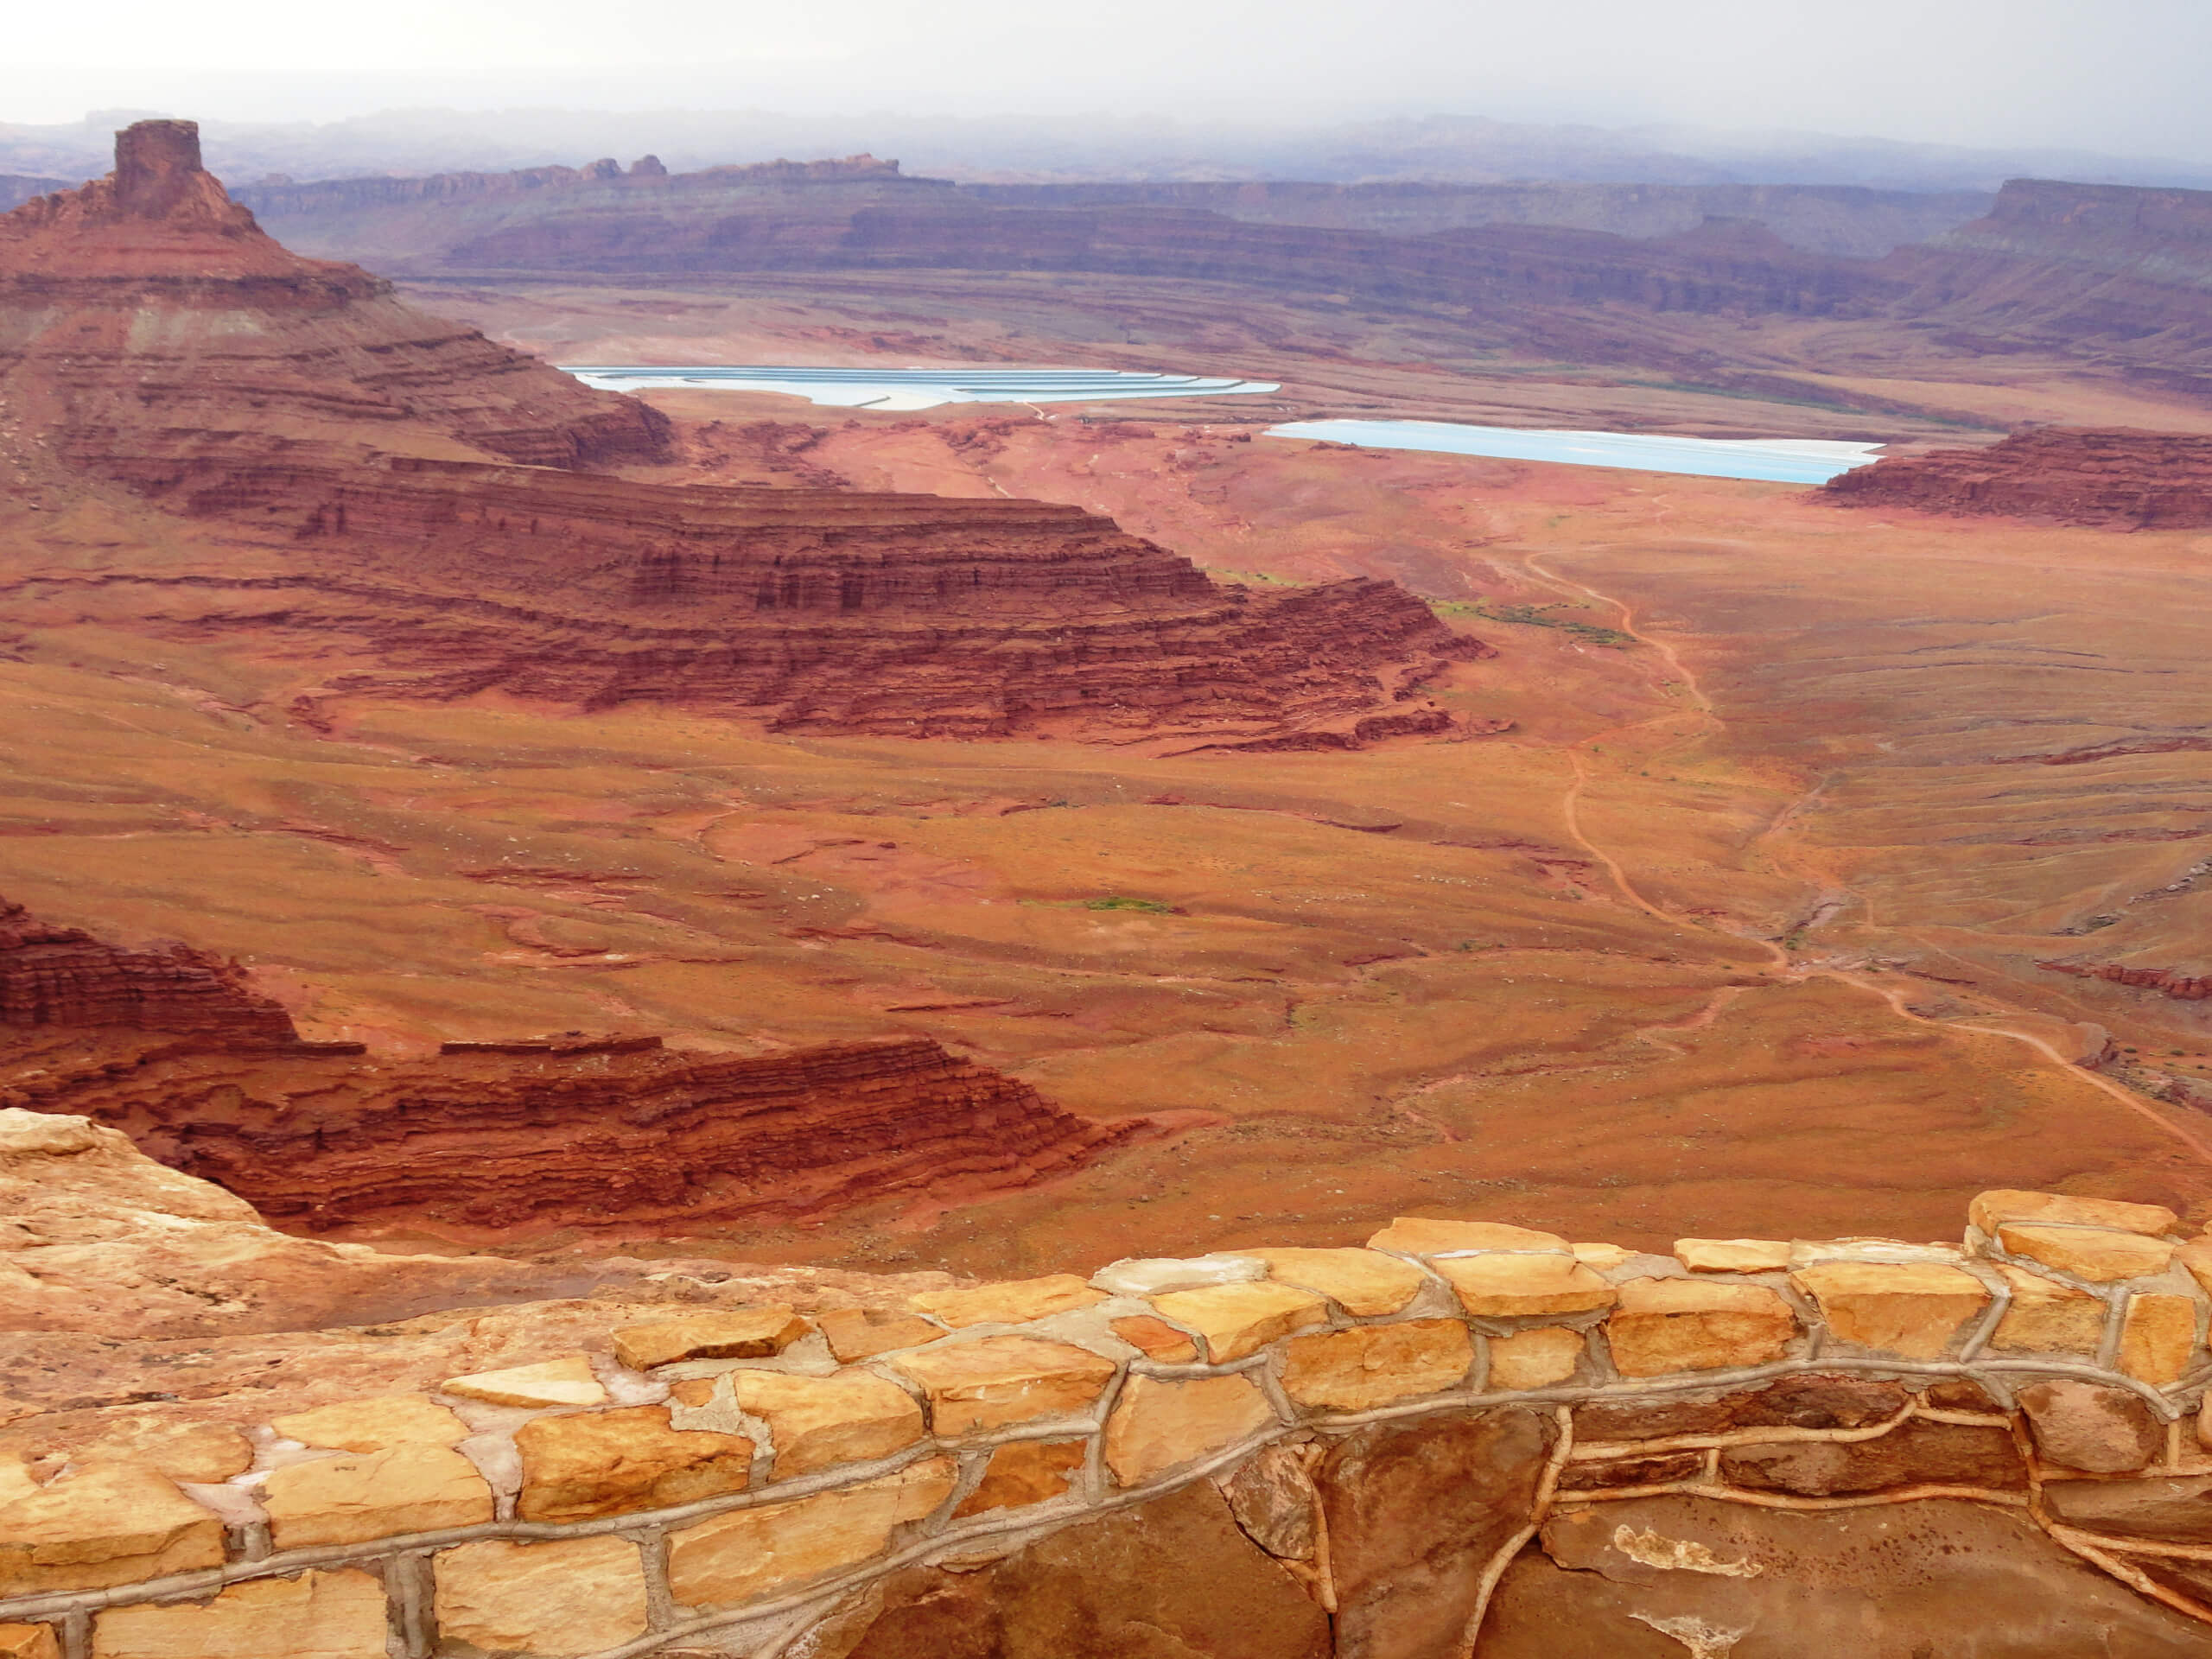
1522;553;2212;1164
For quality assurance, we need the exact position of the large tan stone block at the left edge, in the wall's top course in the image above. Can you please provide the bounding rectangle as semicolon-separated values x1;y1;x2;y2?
0;1465;224;1595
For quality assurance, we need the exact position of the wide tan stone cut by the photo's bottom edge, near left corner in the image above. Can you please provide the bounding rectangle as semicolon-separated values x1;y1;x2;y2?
93;1568;387;1659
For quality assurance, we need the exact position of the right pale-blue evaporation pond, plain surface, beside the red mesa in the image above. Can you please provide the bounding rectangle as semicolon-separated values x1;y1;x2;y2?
1265;420;1880;485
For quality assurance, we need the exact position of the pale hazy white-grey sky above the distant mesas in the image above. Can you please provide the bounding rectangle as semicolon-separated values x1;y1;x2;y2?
0;0;2212;162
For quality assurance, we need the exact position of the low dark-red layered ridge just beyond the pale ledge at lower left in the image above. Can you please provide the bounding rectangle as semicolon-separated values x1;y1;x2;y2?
0;1038;1154;1239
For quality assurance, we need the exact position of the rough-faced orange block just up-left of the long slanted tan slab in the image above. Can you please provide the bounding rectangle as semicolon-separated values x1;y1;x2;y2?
515;1405;752;1522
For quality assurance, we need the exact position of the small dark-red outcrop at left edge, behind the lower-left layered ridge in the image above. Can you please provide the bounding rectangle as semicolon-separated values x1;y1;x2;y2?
0;898;296;1044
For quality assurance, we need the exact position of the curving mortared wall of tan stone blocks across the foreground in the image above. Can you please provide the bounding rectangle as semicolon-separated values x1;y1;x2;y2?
13;1192;2212;1659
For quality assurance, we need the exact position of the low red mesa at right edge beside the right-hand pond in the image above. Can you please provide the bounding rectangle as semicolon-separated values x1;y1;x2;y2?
1822;427;2212;531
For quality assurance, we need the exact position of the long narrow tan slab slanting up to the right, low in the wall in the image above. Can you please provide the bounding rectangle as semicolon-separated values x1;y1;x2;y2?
668;1458;957;1608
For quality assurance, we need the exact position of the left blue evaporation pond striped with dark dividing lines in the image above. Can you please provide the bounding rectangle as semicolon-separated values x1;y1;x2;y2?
562;363;1281;410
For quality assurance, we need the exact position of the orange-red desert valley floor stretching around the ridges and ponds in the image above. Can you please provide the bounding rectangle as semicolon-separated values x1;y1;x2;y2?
13;259;2212;1274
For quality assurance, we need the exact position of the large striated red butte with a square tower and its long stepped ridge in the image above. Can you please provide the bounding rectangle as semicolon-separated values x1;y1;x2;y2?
0;122;1486;743
